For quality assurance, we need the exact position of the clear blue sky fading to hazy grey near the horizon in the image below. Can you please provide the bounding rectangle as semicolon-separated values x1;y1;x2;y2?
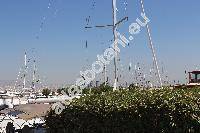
0;0;200;84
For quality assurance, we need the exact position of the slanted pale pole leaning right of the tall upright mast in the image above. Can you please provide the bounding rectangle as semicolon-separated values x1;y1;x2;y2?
140;0;163;88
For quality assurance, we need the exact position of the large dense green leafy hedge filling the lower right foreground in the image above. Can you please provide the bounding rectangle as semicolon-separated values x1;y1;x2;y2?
46;88;200;133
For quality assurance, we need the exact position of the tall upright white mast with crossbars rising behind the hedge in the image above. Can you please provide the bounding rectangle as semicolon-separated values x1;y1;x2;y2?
112;0;118;90
